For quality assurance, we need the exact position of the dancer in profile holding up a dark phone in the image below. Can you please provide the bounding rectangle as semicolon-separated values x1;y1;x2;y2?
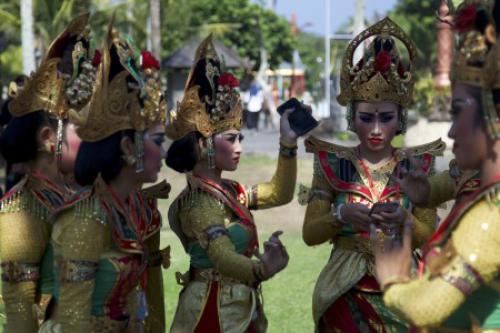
167;36;297;333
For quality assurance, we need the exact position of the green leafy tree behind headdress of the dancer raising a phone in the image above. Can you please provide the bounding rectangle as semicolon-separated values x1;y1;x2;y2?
162;0;295;69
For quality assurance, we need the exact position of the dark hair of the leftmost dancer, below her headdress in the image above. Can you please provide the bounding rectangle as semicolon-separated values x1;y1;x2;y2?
0;111;57;163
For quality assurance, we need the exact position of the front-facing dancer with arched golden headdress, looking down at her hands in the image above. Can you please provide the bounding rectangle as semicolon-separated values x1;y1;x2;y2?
302;18;444;332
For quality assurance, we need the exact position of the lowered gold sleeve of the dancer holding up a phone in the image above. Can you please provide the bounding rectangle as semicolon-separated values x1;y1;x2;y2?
179;192;256;283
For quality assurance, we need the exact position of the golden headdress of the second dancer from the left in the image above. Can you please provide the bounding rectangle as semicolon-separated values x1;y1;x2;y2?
70;17;166;142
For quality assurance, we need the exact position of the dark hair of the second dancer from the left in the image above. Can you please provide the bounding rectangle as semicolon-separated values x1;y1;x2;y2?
75;130;134;186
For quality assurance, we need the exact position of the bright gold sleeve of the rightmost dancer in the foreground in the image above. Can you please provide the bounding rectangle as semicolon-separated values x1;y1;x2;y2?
384;197;500;327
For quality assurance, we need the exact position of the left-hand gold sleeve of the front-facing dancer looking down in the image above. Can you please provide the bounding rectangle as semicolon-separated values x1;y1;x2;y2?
302;159;342;246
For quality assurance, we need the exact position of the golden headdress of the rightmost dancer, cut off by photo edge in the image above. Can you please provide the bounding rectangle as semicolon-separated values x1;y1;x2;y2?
452;0;500;139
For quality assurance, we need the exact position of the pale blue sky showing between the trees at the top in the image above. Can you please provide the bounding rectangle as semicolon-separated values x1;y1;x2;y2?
252;0;397;36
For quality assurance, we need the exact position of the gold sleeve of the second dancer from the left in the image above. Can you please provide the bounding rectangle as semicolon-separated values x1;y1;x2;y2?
52;210;110;333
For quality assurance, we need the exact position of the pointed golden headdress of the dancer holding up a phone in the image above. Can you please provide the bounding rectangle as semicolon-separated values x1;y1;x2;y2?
166;35;242;140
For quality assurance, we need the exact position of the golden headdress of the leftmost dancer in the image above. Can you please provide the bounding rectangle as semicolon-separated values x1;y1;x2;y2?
9;14;98;119
